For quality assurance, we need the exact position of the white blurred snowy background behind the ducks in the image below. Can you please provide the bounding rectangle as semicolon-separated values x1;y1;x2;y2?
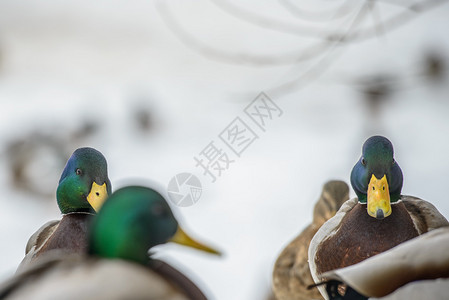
0;0;449;299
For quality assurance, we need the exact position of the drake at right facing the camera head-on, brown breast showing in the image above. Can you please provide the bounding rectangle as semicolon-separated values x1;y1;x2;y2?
309;136;449;294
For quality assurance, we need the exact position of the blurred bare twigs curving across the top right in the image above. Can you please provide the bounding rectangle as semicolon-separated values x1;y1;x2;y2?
157;0;449;94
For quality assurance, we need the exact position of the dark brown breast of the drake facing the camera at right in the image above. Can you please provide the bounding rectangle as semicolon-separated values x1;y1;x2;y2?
315;202;418;274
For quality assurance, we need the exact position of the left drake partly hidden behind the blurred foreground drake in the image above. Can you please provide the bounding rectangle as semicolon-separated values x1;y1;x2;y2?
18;147;111;271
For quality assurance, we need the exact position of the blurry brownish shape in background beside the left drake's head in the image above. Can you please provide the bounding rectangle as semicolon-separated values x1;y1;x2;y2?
5;121;99;199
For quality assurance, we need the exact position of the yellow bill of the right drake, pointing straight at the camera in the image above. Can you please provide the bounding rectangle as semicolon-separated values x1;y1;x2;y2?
367;174;391;220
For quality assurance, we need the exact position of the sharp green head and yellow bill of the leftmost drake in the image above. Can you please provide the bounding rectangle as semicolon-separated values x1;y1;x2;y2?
56;147;111;214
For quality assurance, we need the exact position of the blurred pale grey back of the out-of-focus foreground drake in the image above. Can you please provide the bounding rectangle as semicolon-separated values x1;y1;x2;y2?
0;251;206;300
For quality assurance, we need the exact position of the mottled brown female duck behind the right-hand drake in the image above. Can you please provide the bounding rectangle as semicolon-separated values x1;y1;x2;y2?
273;180;349;300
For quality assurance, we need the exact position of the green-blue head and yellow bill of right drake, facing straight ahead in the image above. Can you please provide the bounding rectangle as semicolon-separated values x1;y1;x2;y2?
351;136;403;219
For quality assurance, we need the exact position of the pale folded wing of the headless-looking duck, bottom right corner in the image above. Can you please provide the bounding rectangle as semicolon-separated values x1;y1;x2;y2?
322;227;449;299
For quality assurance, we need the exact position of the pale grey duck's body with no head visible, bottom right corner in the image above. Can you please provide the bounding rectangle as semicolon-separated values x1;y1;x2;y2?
320;227;449;300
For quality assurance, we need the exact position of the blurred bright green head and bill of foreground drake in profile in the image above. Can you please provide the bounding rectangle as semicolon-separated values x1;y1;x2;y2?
89;186;219;264
